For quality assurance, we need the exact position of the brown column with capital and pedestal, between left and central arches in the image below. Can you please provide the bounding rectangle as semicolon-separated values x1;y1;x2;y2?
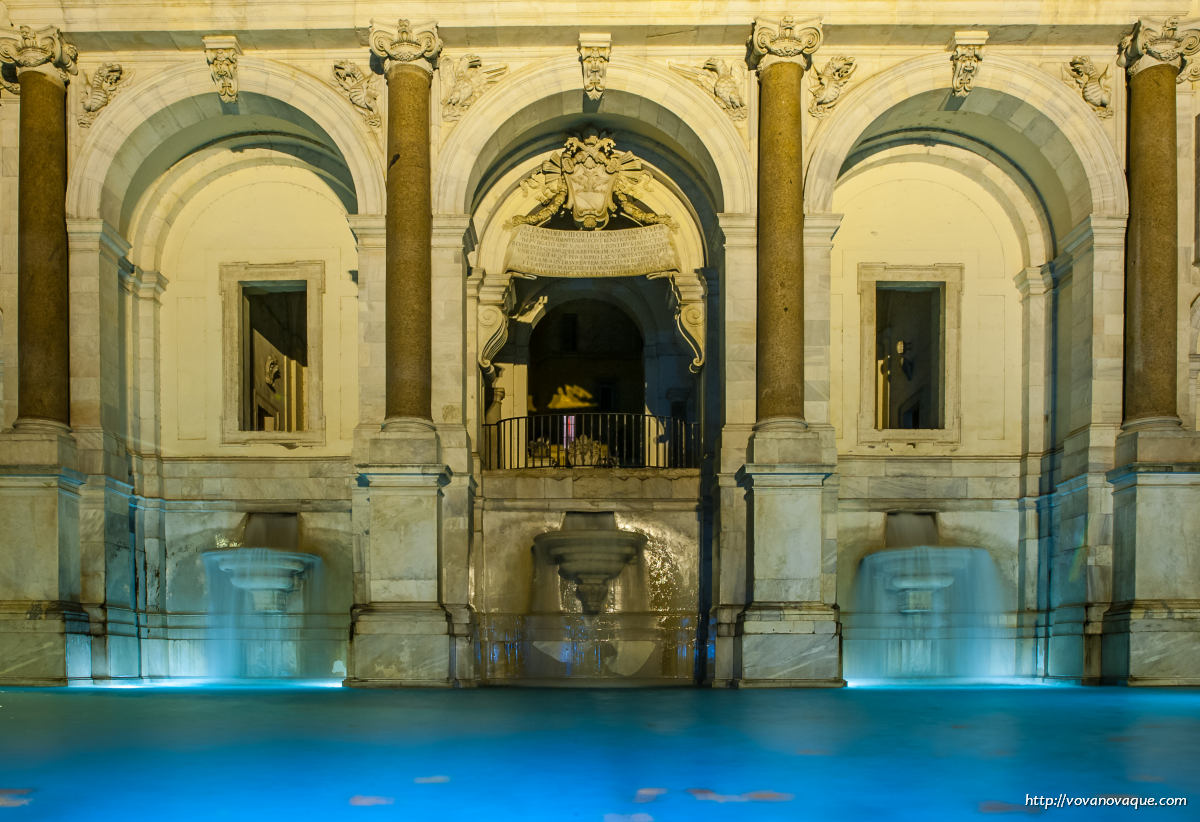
346;20;455;686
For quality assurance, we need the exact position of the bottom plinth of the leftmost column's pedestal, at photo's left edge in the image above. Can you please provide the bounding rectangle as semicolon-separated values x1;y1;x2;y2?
0;601;91;686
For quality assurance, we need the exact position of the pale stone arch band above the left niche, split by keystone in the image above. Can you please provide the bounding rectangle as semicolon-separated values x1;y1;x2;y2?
66;56;384;227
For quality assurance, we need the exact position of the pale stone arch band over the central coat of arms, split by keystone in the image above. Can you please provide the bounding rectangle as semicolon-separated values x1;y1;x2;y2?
433;56;754;214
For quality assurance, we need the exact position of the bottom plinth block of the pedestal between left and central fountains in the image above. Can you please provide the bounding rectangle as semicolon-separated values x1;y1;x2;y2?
343;602;454;688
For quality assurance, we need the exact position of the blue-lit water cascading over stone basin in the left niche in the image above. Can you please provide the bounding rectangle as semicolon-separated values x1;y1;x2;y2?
204;514;323;679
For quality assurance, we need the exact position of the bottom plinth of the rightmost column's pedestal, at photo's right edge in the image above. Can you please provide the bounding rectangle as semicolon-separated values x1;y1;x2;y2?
1100;600;1200;686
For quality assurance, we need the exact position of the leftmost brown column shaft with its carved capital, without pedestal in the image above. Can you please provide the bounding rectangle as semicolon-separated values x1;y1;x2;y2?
0;26;77;428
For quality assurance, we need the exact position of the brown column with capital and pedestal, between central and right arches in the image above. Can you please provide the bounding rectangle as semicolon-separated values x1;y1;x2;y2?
729;17;845;688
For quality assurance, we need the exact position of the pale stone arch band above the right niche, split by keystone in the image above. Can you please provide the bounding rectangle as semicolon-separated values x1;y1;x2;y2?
804;54;1129;232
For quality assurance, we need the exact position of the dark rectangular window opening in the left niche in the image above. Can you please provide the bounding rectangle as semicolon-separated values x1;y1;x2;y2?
240;281;308;432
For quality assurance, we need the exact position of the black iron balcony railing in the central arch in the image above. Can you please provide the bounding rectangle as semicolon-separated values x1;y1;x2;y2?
481;413;700;469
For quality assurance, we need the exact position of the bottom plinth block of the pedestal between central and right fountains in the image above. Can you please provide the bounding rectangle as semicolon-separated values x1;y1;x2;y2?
731;602;846;688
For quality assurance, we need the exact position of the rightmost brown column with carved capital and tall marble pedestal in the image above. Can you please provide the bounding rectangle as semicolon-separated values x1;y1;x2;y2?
1100;18;1200;685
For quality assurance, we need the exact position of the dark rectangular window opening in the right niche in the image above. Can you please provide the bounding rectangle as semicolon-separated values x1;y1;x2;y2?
875;282;946;431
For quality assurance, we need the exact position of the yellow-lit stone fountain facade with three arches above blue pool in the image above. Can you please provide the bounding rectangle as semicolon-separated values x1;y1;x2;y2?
0;0;1200;688
